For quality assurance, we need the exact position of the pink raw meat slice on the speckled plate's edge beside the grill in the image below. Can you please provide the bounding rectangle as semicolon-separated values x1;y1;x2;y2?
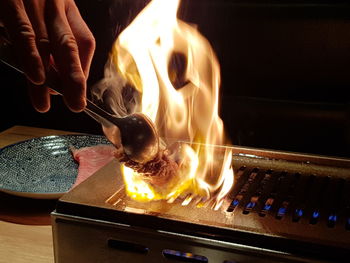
71;145;116;188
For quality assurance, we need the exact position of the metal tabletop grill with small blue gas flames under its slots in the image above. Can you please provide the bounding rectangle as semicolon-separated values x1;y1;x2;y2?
52;147;350;263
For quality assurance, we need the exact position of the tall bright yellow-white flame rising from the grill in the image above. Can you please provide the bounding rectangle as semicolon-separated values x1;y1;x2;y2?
105;0;233;208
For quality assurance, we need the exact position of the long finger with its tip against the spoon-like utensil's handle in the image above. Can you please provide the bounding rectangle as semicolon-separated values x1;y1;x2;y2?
46;0;86;112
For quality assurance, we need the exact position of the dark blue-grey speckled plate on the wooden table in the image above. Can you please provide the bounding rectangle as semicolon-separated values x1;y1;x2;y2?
0;135;109;199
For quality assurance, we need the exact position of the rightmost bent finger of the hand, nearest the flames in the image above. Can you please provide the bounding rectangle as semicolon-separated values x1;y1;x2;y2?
66;1;96;79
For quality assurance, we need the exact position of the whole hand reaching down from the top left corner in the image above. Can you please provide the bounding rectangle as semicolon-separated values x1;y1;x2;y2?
0;0;95;112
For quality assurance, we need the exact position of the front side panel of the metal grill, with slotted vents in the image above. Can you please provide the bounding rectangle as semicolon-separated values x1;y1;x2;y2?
53;213;320;263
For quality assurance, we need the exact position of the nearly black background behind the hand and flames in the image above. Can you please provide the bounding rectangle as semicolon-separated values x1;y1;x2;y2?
0;0;350;157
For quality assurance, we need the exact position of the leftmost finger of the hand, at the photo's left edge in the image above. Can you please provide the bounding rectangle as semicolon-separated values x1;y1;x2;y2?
1;0;45;84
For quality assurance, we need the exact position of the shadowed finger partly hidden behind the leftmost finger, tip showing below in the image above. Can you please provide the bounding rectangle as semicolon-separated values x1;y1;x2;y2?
24;0;50;112
